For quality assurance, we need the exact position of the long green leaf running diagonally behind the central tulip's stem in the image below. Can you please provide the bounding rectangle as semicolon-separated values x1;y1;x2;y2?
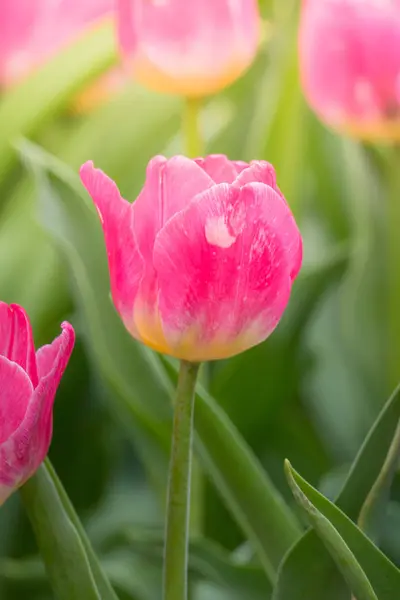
20;142;300;579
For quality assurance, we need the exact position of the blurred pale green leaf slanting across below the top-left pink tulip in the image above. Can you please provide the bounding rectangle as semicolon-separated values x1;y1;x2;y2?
0;23;116;181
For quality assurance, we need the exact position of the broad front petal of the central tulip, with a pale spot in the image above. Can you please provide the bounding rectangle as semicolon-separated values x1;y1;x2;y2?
154;183;300;360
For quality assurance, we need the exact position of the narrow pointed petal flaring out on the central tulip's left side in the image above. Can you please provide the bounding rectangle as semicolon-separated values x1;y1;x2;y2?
80;161;143;327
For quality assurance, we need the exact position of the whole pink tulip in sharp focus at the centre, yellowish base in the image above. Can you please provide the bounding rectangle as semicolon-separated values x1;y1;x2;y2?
81;155;302;361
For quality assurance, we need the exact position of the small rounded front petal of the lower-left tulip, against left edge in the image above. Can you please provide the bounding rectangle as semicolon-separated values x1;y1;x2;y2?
0;356;33;446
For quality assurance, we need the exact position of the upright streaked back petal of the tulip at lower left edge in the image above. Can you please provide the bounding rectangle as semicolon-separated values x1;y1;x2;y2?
0;302;38;387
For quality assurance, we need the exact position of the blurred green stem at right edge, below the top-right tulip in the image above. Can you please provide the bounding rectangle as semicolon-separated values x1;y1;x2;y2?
387;146;400;390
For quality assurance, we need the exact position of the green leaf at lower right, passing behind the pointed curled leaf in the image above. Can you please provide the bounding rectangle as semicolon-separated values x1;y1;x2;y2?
274;389;400;600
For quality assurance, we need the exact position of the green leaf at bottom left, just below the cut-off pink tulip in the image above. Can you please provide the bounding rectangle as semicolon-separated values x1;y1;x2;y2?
20;461;117;600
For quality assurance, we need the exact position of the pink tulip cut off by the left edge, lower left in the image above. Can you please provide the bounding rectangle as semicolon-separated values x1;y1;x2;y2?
0;302;75;504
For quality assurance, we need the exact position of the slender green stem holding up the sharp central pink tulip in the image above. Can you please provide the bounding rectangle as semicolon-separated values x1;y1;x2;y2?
163;361;200;600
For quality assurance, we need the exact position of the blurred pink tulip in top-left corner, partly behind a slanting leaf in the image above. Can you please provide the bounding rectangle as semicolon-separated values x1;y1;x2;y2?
0;0;122;108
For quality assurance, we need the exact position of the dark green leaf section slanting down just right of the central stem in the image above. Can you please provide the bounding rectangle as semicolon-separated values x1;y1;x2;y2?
195;386;300;581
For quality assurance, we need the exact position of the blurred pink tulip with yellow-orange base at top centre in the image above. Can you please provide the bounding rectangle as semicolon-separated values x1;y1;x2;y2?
118;0;259;96
